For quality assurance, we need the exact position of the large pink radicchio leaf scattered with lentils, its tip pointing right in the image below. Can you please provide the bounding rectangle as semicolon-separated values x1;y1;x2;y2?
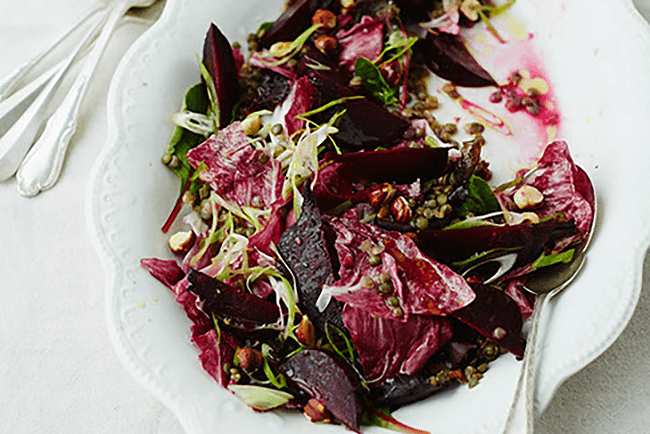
319;210;474;322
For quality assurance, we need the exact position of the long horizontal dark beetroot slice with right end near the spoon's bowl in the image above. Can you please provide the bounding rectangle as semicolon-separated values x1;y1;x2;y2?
415;221;577;264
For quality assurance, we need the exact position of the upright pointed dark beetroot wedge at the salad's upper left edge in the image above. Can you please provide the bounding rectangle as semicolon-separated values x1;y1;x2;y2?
203;24;240;127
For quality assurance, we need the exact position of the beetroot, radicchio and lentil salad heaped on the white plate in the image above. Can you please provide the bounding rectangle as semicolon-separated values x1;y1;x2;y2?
141;0;594;432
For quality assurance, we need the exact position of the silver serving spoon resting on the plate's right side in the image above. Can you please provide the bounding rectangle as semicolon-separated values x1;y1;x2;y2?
503;190;597;434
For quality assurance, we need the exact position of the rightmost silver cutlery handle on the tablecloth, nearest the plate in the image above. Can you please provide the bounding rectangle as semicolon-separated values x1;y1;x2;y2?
16;2;128;197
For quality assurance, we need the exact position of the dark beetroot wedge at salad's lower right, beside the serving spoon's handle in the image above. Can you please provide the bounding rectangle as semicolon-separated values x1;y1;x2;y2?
451;283;526;359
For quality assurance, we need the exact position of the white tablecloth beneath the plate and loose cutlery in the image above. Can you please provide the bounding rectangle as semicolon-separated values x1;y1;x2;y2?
0;0;650;434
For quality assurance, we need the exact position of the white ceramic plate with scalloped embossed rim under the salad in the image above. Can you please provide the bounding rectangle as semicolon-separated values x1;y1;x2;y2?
87;0;650;434
